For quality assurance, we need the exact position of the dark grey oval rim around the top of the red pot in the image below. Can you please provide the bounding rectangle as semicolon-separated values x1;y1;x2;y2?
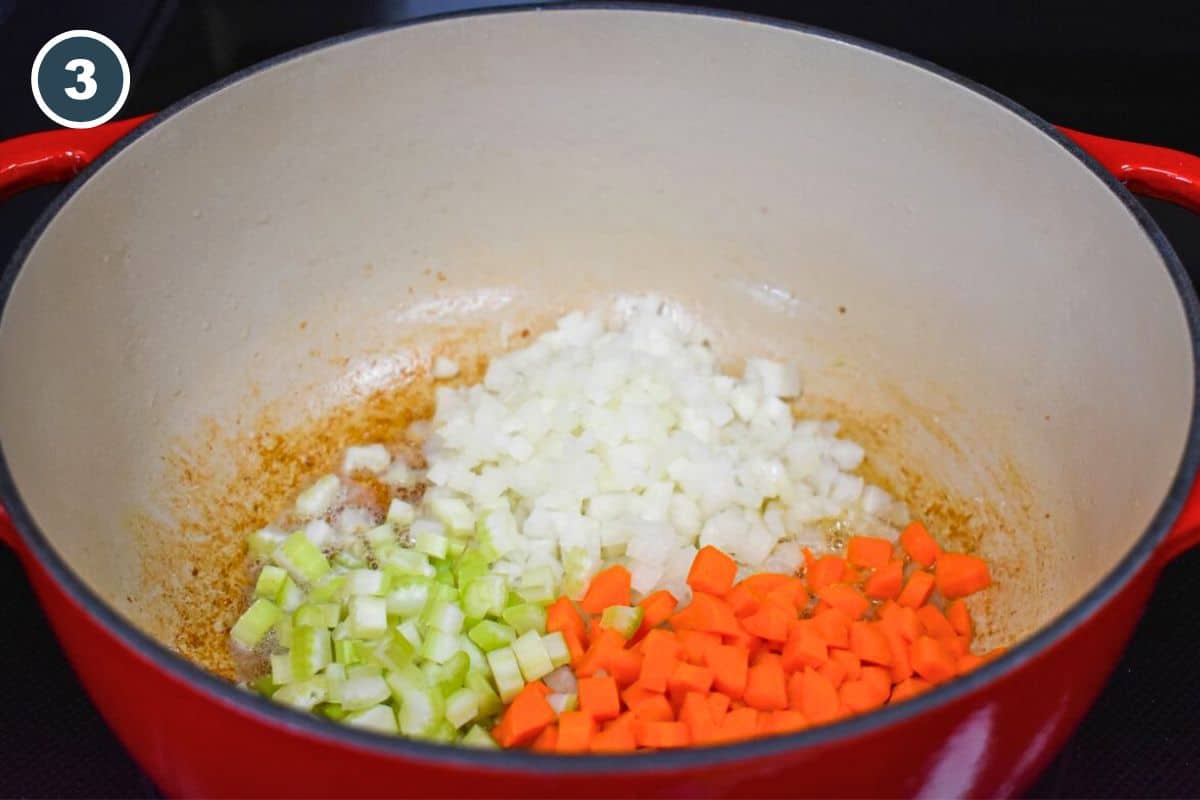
0;2;1200;775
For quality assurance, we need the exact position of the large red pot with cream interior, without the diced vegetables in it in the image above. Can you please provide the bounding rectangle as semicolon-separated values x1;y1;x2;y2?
0;7;1200;796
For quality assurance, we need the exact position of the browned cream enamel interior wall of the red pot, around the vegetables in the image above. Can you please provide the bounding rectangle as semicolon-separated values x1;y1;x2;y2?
0;10;1193;676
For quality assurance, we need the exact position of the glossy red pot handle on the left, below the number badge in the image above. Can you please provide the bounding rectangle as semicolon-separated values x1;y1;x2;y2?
0;114;152;201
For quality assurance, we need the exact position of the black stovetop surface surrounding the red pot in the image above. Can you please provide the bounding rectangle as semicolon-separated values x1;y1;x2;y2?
0;0;1200;798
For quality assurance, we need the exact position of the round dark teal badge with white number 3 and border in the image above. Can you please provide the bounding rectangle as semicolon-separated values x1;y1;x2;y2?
30;30;130;128
